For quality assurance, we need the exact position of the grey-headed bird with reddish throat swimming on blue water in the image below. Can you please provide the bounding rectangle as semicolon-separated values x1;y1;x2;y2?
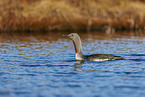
64;33;124;61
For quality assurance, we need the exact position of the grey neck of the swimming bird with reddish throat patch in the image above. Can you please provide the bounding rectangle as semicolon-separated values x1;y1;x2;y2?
73;37;84;60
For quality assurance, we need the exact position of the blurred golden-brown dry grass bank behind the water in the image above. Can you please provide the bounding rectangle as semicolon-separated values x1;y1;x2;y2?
0;0;145;31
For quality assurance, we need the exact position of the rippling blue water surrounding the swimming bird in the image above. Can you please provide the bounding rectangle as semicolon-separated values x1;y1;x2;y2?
0;32;145;97
